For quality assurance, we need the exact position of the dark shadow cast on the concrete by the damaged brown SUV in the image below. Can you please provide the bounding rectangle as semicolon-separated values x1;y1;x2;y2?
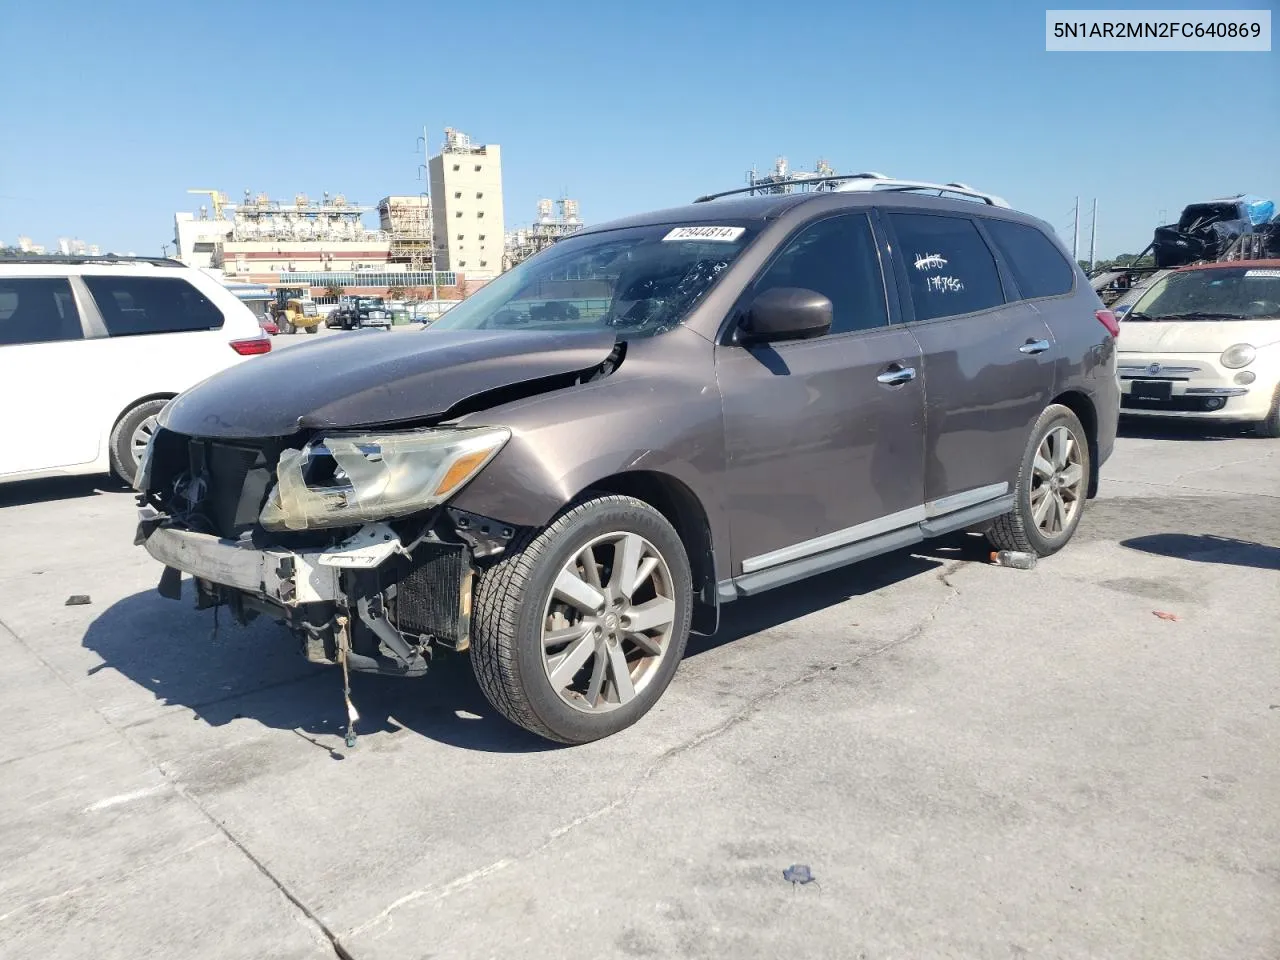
82;552;943;760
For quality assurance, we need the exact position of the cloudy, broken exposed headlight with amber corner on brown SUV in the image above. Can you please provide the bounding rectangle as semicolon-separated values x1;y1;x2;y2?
259;426;511;530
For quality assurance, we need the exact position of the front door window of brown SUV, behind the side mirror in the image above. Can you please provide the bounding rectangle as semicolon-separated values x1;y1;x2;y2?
753;214;888;334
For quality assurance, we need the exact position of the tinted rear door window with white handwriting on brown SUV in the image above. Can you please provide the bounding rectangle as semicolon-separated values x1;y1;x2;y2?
888;214;1005;320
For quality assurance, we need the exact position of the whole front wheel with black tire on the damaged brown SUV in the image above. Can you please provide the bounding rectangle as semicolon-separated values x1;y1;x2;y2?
471;495;692;744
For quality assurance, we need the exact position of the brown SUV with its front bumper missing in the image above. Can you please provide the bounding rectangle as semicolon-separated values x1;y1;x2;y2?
136;179;1119;742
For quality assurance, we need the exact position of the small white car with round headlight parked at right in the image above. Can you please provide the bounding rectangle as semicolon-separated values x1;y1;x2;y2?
1116;260;1280;436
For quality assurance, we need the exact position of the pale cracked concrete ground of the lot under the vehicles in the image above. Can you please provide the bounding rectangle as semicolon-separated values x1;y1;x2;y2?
0;417;1280;960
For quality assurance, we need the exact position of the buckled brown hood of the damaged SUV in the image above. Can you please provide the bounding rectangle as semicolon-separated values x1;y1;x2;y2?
160;329;616;439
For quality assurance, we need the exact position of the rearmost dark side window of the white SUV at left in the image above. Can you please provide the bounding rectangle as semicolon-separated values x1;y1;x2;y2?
83;276;223;337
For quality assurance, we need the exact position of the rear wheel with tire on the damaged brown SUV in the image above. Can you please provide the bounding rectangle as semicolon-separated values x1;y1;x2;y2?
987;403;1093;557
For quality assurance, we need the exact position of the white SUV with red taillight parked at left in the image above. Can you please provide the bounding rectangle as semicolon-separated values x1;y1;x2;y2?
0;256;271;483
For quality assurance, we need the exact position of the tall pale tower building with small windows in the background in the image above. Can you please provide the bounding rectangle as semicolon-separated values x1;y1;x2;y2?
429;128;506;280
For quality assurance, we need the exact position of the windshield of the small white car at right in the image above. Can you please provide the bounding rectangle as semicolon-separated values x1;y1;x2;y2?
1125;264;1280;323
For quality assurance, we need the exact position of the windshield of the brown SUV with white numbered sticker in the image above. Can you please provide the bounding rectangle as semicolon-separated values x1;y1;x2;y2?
429;221;758;338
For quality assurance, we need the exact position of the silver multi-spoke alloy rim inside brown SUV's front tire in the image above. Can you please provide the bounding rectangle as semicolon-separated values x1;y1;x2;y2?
541;532;676;713
